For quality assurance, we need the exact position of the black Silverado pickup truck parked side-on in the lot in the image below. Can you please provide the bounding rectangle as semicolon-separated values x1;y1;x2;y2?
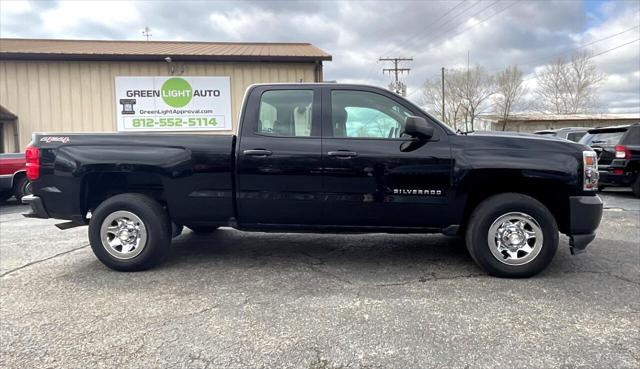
24;84;602;277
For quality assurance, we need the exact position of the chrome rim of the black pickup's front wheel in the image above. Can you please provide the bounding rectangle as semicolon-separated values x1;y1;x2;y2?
488;212;544;265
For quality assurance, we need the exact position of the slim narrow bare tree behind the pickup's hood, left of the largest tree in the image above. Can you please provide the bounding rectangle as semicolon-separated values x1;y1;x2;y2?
493;65;527;131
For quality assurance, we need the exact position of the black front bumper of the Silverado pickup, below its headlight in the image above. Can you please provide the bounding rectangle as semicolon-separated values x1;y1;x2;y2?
568;195;602;254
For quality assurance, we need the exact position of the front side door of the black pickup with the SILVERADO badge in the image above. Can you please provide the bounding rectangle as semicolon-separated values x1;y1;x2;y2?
322;86;451;227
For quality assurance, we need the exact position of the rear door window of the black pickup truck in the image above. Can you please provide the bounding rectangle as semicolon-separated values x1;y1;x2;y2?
256;90;313;137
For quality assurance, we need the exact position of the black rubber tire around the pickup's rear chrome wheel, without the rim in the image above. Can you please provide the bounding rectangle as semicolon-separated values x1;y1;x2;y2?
89;194;171;271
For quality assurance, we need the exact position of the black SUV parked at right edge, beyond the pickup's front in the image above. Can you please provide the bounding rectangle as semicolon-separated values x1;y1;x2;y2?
580;123;640;197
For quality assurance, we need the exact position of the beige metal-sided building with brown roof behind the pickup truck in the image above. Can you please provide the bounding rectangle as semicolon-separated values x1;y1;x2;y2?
0;39;331;152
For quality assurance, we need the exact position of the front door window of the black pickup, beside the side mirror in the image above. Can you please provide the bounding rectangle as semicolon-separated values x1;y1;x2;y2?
331;90;413;138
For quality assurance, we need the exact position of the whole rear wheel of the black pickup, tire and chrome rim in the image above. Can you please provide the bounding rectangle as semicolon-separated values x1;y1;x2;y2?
89;194;171;271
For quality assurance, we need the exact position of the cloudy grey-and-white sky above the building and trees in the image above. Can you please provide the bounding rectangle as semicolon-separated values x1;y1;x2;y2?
0;0;640;113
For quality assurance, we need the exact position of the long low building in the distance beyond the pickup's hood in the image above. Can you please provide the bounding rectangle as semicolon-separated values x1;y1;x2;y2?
474;113;640;132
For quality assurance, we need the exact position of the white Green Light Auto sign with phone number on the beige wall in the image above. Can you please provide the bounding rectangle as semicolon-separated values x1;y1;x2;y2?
116;77;231;131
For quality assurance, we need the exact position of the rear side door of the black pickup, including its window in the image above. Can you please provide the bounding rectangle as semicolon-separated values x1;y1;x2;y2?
236;85;322;225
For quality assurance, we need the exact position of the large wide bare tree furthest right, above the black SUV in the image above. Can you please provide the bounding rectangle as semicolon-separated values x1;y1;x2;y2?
536;52;605;114
